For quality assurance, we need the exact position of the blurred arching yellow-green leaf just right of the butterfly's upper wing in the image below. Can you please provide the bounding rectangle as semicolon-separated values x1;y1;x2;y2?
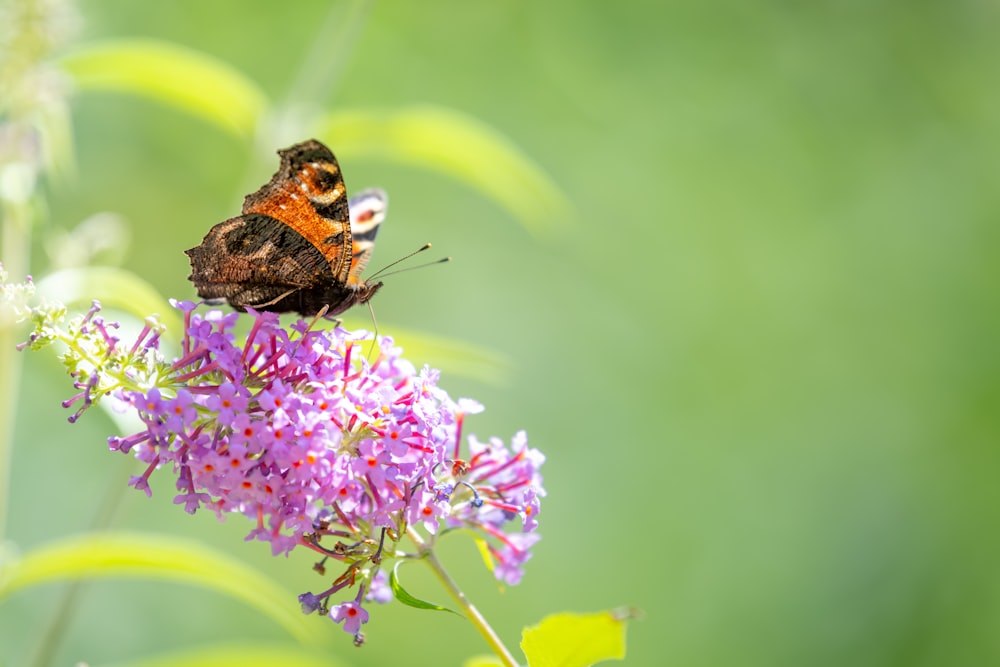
317;106;570;234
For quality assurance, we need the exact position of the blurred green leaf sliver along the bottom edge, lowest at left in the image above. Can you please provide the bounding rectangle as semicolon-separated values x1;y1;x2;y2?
109;642;344;667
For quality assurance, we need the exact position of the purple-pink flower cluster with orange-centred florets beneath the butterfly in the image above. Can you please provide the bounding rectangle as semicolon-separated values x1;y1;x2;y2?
109;302;544;635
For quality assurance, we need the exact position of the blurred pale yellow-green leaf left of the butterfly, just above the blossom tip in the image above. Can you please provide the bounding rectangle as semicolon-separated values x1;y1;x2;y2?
37;266;184;336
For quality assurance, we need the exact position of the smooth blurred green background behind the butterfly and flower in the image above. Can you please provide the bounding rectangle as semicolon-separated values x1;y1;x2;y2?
0;0;1000;667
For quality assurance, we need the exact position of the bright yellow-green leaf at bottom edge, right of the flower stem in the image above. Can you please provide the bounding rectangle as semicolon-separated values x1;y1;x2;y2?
521;611;632;667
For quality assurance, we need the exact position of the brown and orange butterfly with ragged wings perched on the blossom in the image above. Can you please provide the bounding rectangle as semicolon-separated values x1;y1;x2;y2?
185;139;388;316
